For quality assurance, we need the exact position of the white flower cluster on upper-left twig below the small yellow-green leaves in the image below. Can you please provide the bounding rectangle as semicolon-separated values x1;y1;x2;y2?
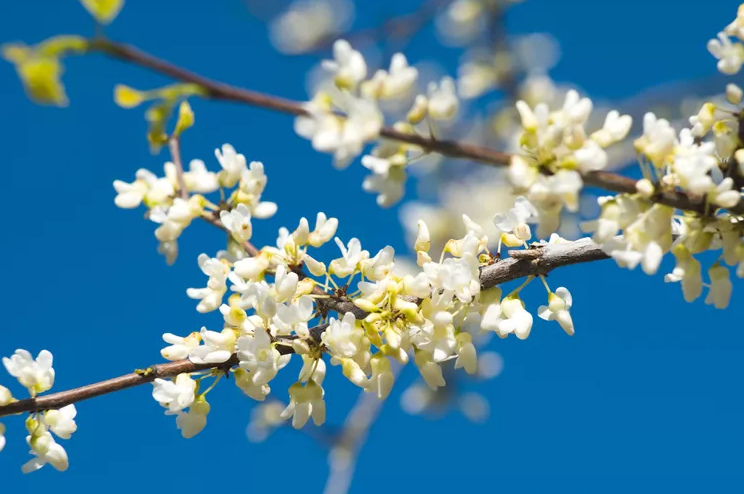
114;144;276;264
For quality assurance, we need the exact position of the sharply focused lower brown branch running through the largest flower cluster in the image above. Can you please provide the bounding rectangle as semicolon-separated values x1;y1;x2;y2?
0;239;607;417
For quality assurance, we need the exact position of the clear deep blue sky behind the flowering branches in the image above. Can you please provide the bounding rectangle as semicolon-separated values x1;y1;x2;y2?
0;0;744;494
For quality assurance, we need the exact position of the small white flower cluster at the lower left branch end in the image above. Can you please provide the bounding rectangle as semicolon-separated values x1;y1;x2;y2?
0;350;77;473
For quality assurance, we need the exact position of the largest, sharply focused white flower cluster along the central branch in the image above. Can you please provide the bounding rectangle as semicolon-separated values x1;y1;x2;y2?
147;185;574;437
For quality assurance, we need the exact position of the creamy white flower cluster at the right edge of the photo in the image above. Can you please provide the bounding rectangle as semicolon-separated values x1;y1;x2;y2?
585;6;744;308
